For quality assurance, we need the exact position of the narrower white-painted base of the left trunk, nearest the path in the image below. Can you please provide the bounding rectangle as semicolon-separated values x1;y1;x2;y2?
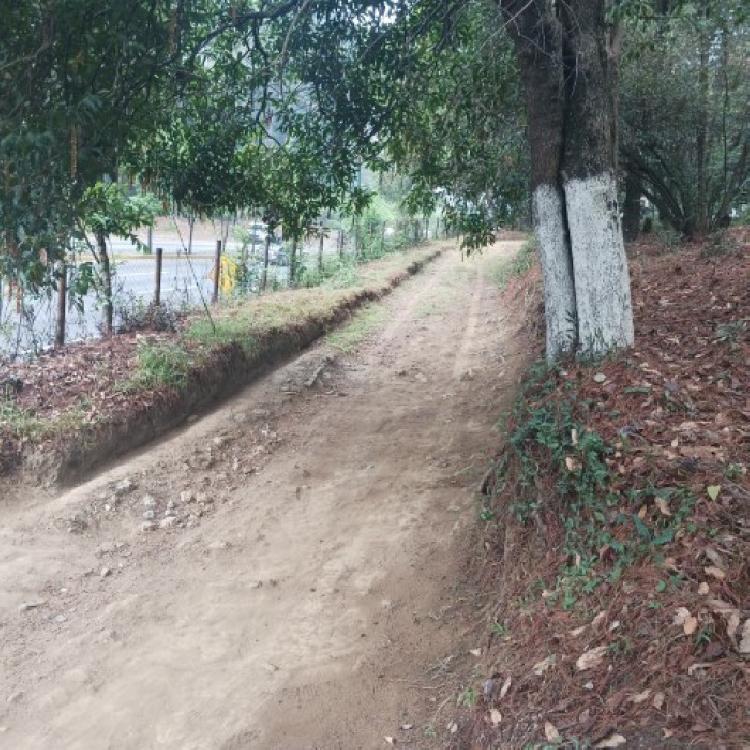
532;185;577;362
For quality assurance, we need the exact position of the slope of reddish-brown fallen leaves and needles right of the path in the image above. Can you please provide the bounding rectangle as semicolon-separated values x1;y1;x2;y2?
462;234;750;748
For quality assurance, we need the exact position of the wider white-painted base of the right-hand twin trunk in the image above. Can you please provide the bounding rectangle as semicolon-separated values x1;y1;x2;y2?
568;173;634;356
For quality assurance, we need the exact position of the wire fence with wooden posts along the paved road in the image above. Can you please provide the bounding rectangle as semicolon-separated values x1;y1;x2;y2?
0;219;445;360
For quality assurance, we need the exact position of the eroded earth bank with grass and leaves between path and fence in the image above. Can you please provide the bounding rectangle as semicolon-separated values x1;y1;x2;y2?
0;246;441;485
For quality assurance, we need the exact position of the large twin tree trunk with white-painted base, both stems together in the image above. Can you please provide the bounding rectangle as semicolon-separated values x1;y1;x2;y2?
503;0;633;360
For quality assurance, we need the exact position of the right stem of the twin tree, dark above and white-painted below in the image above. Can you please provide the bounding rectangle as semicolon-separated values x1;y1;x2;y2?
561;0;634;356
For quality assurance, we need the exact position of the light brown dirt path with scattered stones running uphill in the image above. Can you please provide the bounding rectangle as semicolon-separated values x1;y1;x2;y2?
0;243;521;750
